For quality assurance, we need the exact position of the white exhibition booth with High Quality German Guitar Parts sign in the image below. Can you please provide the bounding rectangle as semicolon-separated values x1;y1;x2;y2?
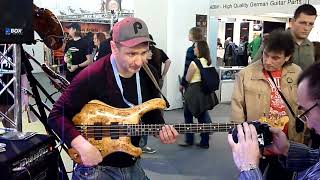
209;0;320;102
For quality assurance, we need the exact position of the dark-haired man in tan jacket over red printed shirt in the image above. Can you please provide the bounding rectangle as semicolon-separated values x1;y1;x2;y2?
231;31;303;180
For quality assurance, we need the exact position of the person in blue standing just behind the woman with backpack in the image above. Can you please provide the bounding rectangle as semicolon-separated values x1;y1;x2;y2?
179;27;203;94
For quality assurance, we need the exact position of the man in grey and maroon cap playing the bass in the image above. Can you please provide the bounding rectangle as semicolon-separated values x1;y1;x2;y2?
48;17;178;180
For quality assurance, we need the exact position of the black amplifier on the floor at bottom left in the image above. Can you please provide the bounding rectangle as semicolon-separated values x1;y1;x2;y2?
0;134;59;180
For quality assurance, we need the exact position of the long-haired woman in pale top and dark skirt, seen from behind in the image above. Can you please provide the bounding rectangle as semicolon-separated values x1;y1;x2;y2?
179;41;214;149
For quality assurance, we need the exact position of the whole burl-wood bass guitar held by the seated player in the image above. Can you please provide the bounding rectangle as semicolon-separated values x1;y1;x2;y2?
68;98;284;164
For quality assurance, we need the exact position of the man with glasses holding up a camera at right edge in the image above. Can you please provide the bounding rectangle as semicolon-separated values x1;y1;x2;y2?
228;63;320;180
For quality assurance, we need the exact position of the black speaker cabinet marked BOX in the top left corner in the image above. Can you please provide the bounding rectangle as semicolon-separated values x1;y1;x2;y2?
0;0;34;44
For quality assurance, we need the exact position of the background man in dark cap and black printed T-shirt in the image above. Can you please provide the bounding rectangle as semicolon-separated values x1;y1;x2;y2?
64;23;92;82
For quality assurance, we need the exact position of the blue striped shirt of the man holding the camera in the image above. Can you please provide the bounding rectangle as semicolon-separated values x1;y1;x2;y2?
238;142;320;180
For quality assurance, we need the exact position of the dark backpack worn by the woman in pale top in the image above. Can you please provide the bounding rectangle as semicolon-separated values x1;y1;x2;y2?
194;59;220;94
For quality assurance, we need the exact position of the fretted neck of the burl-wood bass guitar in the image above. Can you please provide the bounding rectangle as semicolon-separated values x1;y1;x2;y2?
127;123;237;136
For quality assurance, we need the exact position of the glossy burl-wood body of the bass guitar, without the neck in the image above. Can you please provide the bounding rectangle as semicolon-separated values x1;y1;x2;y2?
69;98;166;163
